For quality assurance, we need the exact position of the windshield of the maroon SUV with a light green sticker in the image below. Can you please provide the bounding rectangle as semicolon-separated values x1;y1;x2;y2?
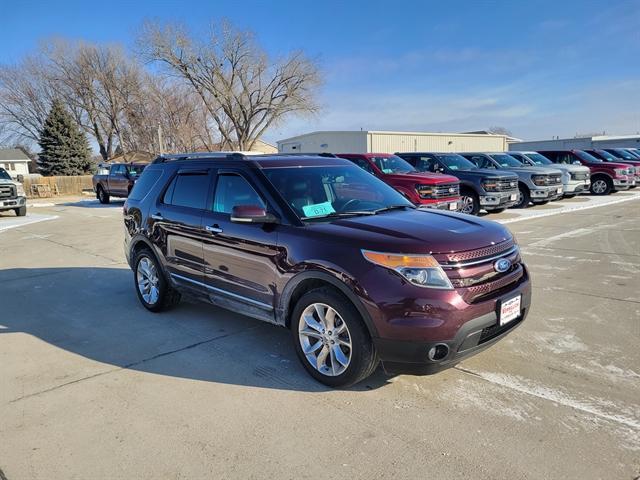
263;165;415;220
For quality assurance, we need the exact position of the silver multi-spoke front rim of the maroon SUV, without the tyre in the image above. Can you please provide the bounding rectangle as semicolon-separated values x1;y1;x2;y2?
298;303;353;377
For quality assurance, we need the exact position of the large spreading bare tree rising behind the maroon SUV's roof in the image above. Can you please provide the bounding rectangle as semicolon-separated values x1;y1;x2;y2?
138;22;320;150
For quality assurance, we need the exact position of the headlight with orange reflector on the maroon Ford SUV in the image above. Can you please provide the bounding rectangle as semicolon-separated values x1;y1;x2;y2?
362;250;453;290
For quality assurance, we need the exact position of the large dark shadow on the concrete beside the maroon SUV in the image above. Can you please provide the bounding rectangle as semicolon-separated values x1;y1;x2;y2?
0;268;389;392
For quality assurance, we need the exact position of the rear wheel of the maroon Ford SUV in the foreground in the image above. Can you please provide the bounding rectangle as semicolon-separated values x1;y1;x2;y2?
133;248;180;312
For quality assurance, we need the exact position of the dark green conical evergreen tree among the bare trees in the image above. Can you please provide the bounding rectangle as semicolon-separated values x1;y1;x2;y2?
38;99;91;176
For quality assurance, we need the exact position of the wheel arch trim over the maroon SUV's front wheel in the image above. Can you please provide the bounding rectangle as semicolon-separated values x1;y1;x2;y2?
276;270;378;338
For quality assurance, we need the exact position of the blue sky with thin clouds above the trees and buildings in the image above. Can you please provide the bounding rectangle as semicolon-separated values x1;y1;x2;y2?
0;0;640;141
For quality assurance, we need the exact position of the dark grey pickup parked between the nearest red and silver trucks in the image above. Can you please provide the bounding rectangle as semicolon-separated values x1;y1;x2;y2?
396;152;518;215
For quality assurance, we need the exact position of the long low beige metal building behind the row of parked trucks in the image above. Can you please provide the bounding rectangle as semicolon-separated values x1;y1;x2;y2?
278;130;510;153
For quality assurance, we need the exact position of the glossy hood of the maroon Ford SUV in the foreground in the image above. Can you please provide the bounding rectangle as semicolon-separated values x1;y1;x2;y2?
308;210;512;253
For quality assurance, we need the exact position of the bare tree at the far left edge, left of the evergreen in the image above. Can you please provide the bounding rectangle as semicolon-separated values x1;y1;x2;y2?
0;55;55;144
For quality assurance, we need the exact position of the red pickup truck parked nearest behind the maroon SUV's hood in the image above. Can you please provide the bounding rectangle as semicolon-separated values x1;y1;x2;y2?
337;153;460;211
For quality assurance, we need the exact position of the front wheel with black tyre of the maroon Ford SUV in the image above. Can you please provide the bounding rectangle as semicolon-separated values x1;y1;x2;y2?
291;288;378;387
